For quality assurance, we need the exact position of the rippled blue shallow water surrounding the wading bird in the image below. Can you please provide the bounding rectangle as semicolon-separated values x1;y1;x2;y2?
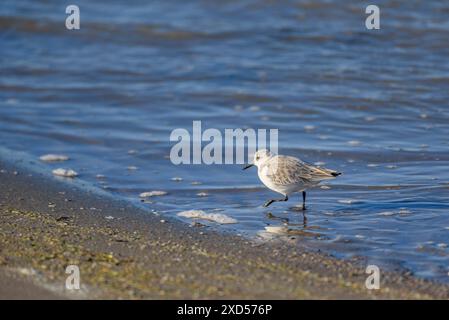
0;0;449;281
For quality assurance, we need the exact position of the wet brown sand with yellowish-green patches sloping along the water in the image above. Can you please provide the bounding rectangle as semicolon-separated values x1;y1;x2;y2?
0;160;449;299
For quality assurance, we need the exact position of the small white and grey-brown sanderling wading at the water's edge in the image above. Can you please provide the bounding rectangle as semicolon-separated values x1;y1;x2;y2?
243;149;341;210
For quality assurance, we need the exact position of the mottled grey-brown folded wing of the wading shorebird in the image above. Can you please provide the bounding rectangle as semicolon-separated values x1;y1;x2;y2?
265;156;337;185
